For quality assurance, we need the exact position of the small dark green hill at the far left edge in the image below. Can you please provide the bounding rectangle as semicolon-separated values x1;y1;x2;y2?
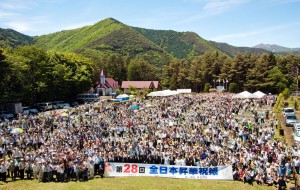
0;28;33;48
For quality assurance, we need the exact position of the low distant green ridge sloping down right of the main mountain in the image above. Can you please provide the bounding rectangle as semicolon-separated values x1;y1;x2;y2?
209;41;268;57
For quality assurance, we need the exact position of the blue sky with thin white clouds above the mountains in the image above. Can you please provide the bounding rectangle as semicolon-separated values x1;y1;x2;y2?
0;0;300;48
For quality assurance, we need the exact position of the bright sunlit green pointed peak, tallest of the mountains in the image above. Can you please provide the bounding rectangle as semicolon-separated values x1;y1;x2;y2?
34;18;172;66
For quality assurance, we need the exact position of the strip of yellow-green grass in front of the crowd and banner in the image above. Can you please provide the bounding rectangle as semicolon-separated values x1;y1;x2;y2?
0;177;275;190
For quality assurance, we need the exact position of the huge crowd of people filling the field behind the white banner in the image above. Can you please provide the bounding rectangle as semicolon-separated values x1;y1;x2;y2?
0;93;300;188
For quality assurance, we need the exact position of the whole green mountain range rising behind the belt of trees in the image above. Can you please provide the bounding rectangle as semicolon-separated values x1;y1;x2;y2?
0;18;300;59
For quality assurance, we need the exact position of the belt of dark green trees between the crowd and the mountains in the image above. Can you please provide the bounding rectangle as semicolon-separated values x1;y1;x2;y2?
0;46;300;104
